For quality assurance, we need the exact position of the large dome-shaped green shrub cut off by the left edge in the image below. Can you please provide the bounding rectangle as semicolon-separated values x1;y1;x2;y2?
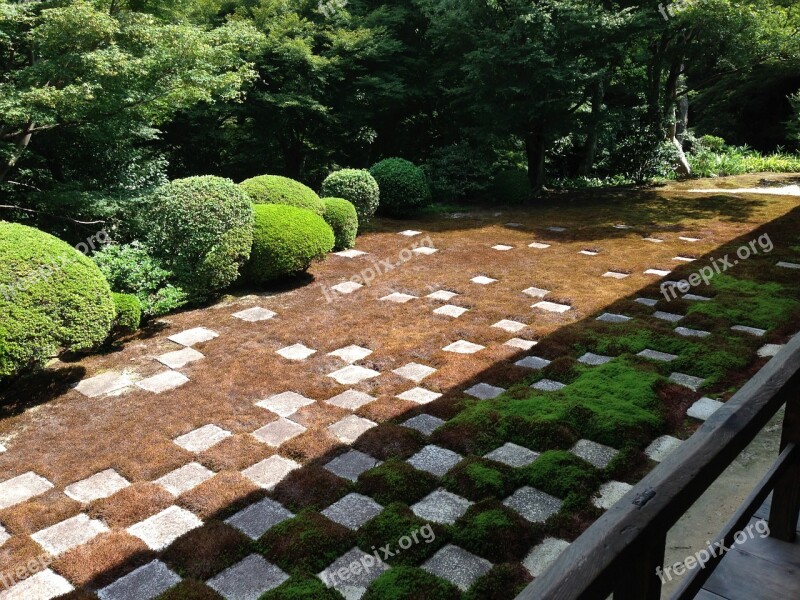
0;222;115;378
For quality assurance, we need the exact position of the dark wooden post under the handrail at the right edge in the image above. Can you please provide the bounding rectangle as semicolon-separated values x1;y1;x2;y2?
769;389;800;542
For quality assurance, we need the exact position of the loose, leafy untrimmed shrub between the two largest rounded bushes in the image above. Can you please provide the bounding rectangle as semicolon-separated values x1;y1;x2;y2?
92;242;186;317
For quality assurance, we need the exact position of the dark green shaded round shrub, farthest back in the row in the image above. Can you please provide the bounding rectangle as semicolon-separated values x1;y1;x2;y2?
369;158;431;217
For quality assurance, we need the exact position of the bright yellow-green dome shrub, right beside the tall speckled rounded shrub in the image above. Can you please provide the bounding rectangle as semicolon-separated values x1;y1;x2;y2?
246;204;335;283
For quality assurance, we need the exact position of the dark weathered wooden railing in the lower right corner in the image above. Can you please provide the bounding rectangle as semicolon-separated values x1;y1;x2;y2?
517;334;800;600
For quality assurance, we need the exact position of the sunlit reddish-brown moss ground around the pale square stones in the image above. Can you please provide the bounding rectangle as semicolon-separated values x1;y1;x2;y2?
0;176;800;583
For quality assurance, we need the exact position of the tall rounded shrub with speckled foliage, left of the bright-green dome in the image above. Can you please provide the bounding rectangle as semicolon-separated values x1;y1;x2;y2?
143;176;253;302
